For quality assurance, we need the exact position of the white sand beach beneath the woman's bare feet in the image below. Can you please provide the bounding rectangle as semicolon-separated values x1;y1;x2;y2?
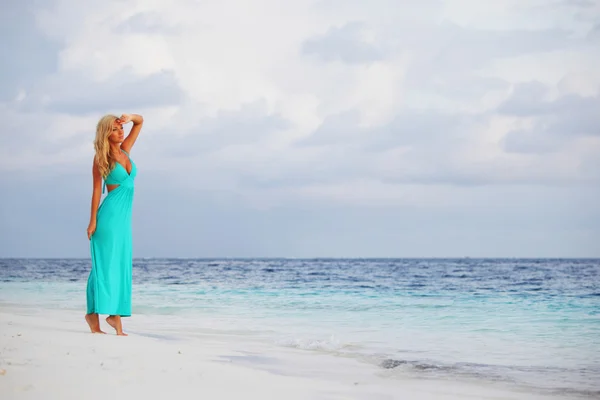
0;304;576;400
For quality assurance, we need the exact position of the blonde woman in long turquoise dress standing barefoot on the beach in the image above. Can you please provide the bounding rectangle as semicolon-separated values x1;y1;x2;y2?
85;114;144;336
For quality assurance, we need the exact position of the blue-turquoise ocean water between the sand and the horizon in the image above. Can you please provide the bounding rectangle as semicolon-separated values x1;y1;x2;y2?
0;258;600;398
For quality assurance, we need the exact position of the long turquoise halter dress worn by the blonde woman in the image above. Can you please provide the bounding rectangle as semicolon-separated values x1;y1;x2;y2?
87;150;137;317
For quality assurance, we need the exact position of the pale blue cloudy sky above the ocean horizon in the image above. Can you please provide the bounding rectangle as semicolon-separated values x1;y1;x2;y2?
0;0;600;258
